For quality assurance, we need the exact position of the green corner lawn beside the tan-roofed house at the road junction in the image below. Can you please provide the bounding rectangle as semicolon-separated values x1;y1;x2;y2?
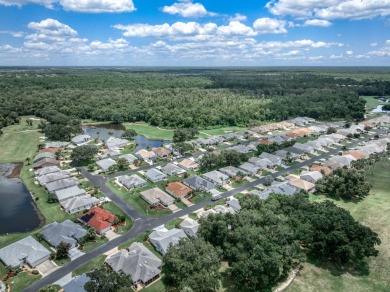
107;180;172;218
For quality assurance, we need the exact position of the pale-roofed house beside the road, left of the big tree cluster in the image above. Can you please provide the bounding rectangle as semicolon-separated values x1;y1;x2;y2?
149;228;187;255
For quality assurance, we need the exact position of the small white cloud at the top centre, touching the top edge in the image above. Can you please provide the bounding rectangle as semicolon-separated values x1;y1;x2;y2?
162;0;217;18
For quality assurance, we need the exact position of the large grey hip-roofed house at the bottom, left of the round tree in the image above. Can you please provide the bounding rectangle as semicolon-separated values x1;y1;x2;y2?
106;242;162;287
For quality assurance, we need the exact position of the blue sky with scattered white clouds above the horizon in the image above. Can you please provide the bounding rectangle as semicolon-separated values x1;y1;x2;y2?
0;0;390;66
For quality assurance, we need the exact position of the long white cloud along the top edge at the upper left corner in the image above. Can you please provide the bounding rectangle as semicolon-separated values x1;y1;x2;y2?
0;0;136;13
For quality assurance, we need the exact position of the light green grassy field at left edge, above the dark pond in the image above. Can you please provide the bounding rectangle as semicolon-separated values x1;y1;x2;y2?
0;117;43;163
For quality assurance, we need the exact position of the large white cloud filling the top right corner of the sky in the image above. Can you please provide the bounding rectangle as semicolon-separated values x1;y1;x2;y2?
266;0;390;19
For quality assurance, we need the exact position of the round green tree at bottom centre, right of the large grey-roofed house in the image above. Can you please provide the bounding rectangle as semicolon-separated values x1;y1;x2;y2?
162;238;220;291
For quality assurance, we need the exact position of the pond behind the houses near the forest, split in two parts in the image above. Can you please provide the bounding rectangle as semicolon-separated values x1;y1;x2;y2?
83;124;171;151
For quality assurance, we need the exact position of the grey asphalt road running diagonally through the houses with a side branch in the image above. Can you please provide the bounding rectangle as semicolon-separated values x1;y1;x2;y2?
24;129;388;292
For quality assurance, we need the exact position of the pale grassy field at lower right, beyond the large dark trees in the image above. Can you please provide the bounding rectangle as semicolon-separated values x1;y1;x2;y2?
285;159;390;292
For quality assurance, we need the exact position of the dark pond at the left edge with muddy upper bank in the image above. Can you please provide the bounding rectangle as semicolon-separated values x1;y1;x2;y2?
0;164;41;235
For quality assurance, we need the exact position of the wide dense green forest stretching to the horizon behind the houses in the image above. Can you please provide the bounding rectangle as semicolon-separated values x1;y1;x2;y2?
0;68;390;132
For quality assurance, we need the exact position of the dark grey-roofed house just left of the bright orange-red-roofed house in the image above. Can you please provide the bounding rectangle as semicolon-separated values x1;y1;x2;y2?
41;219;88;247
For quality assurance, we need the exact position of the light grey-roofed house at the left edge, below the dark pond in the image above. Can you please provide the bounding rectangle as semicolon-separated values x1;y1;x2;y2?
0;236;50;268
